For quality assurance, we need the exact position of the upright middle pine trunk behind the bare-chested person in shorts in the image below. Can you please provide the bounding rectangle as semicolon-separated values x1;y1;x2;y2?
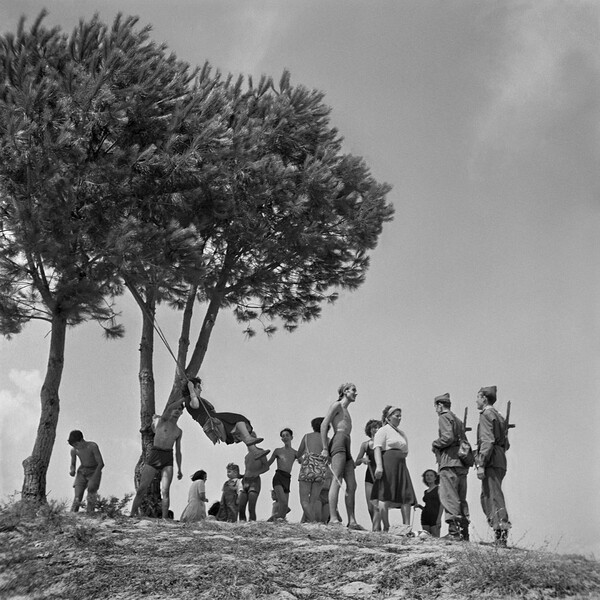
134;288;161;517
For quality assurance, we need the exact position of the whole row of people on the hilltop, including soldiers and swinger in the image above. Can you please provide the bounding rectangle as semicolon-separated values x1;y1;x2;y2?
69;379;511;546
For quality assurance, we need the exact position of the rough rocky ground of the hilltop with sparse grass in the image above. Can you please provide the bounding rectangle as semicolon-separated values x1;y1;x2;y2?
0;511;600;600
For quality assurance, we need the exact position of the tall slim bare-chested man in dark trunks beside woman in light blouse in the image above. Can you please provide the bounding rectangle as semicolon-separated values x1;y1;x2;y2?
321;383;363;529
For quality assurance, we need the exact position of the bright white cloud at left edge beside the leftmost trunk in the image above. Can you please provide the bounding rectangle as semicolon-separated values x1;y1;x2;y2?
0;369;42;498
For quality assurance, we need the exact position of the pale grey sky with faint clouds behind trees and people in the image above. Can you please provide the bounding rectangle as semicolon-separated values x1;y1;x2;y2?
0;0;600;558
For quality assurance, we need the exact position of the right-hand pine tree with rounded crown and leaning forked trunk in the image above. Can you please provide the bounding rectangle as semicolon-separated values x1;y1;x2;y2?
163;72;394;402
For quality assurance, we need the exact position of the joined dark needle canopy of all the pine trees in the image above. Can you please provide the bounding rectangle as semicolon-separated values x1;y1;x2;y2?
0;12;393;504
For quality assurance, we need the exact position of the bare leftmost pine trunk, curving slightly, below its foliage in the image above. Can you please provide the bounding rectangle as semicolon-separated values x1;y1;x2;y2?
21;314;67;503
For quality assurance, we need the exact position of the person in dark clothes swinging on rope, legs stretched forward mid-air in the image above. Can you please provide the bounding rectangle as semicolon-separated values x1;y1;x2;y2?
181;377;270;460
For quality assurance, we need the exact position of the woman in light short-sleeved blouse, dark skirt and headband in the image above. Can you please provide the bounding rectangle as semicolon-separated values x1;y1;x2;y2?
371;406;417;531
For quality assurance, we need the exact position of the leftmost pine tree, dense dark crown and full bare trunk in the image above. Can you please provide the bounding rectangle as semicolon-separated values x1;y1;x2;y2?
0;12;202;501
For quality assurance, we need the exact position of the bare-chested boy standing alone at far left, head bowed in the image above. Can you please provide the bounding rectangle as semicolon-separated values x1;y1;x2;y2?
67;429;104;513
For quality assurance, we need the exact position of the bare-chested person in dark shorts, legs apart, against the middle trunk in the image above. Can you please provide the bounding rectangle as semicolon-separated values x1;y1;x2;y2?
131;402;183;519
